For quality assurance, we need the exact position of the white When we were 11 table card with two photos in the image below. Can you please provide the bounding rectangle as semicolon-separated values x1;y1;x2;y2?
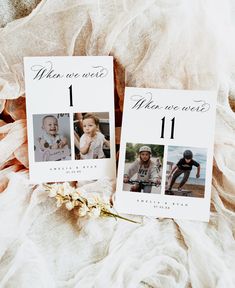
115;88;216;221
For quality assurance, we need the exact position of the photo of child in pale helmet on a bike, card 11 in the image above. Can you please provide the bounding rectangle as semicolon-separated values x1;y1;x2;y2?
123;143;164;194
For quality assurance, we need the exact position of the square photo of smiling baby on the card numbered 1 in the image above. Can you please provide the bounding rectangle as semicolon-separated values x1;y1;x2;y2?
33;114;71;162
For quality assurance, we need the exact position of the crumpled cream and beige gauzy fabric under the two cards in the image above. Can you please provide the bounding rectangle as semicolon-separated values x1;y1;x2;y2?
0;0;235;288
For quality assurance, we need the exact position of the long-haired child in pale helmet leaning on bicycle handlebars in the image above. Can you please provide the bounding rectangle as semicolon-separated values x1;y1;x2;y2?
123;145;161;193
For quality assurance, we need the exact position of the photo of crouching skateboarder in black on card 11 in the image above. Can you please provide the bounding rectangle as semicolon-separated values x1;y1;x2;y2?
165;146;207;198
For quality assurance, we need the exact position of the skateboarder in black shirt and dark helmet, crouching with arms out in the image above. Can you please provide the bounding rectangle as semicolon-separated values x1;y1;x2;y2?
167;150;200;194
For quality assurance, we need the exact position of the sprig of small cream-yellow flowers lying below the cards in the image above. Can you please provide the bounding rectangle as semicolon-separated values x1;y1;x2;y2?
44;182;139;223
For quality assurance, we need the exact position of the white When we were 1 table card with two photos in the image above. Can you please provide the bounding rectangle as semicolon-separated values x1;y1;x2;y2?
24;56;115;183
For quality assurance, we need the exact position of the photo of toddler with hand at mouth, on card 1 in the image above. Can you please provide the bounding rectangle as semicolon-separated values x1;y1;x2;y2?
74;112;110;160
